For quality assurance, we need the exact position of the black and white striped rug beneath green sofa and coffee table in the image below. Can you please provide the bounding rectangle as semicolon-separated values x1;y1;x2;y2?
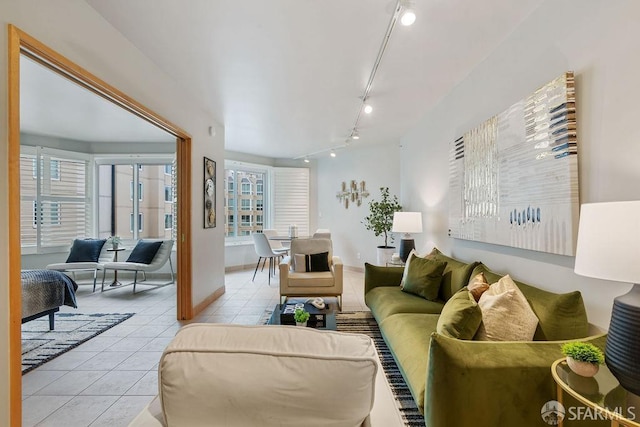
261;311;425;427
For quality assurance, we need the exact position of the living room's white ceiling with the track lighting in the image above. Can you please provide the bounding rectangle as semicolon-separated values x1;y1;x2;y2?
27;0;543;158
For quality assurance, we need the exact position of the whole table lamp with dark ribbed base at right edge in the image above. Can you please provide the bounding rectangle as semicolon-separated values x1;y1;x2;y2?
574;201;640;394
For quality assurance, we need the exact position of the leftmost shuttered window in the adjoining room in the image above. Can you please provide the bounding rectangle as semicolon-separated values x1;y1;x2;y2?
20;146;92;254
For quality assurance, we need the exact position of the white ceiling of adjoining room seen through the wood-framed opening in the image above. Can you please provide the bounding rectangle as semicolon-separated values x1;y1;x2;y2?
20;56;176;143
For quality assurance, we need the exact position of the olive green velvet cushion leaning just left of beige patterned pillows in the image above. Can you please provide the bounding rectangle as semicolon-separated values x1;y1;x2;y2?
437;287;482;340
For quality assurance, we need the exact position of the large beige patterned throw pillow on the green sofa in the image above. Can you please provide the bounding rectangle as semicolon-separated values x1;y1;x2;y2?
475;275;538;341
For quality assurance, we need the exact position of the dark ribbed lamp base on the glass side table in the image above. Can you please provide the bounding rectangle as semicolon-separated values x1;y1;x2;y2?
605;284;640;394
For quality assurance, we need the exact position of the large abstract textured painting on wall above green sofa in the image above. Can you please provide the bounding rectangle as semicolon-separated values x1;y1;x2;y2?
449;72;580;256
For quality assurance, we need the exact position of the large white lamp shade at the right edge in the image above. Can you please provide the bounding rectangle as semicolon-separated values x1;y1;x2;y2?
574;201;640;283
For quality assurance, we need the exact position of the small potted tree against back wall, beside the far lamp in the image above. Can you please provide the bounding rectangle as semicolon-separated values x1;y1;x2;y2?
362;187;402;265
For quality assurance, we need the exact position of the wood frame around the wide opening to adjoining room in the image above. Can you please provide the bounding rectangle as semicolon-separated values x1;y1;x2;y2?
8;24;193;427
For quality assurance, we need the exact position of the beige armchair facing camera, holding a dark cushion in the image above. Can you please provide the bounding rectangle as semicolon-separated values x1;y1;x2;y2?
280;239;342;310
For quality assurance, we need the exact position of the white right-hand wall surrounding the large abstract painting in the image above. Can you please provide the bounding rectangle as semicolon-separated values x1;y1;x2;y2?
401;0;640;328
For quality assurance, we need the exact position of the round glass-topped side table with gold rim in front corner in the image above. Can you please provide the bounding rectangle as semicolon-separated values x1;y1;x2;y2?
551;358;640;427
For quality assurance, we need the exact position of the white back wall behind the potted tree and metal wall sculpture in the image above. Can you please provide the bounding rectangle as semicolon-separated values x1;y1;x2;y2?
317;143;403;268
